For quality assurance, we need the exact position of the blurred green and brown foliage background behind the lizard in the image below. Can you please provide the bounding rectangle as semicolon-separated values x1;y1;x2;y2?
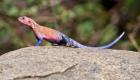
0;0;140;54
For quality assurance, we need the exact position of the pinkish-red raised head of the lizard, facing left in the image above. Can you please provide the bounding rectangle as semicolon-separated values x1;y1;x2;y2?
18;16;37;28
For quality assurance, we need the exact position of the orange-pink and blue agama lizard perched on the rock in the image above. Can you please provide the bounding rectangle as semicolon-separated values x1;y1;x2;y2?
18;16;125;48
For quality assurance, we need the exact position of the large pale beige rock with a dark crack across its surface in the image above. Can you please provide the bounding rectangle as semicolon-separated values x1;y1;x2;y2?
0;47;140;80
